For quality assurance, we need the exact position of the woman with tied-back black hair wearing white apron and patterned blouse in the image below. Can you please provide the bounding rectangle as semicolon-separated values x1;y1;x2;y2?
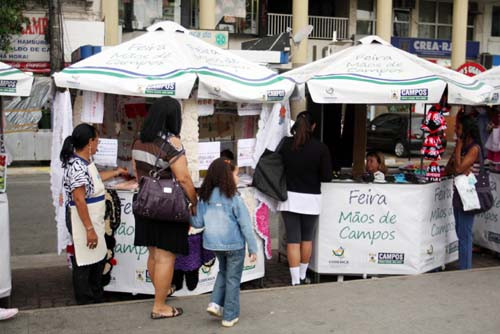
60;123;128;304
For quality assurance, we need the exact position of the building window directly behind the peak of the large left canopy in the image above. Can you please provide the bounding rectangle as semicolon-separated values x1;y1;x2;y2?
119;0;181;31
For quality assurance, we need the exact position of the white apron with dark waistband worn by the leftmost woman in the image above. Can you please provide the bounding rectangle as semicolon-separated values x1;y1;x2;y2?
70;163;108;266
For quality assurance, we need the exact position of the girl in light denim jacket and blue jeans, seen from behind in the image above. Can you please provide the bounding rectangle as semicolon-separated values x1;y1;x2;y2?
191;158;257;327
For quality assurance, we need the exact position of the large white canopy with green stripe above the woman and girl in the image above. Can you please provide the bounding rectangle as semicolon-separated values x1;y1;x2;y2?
54;21;294;102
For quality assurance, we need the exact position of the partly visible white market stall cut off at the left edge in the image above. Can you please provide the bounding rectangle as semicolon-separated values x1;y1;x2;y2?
0;62;33;298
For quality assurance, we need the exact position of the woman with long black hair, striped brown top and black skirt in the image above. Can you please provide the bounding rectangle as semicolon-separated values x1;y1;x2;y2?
132;97;197;319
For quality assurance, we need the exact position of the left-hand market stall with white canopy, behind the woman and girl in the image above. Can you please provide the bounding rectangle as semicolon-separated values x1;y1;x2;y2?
54;22;294;295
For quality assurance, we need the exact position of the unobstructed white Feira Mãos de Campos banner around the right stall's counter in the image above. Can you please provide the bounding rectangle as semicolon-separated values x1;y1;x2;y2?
311;181;457;274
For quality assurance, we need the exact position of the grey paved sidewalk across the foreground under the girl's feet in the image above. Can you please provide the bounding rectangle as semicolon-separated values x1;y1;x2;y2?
0;267;500;334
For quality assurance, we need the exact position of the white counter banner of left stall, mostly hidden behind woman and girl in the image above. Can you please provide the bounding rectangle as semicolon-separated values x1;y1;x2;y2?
104;191;265;296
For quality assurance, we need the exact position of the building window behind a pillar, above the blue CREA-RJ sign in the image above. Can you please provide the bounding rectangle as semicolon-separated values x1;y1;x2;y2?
418;0;477;40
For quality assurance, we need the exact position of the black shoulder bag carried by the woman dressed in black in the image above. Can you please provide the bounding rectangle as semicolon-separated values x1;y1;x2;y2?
252;137;288;201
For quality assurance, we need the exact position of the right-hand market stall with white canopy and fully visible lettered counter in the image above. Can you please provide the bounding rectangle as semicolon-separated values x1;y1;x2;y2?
280;36;491;275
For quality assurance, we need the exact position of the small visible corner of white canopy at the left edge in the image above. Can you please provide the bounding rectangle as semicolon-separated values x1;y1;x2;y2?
0;62;33;96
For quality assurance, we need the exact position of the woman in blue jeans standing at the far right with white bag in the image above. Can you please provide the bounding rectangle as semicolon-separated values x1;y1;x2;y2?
450;113;482;270
